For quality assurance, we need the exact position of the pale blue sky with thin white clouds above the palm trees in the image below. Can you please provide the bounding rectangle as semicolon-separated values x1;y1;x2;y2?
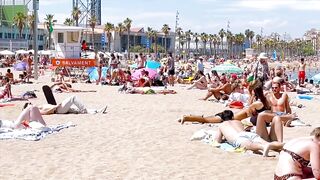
39;0;320;38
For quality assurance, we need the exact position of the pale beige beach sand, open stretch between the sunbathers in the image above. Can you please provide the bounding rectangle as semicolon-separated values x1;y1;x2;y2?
0;69;320;180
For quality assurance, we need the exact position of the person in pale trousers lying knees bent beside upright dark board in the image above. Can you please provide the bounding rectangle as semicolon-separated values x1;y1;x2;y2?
38;96;107;115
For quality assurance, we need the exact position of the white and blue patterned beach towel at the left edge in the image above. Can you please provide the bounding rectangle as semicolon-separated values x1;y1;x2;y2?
0;122;75;141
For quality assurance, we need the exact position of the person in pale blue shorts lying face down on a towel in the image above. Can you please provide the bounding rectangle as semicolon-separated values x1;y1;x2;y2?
215;120;283;157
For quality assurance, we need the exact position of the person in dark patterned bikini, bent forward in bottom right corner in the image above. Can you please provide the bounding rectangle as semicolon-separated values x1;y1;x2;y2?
274;127;320;180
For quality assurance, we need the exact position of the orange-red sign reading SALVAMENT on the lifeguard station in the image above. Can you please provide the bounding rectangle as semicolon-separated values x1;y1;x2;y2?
52;59;96;67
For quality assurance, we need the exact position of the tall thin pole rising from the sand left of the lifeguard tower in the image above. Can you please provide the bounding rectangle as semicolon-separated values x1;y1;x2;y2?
33;0;39;80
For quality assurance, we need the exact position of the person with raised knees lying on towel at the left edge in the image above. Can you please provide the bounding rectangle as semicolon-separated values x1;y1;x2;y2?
0;105;47;129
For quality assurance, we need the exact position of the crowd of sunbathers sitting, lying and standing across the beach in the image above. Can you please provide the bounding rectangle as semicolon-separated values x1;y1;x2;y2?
0;48;320;179
